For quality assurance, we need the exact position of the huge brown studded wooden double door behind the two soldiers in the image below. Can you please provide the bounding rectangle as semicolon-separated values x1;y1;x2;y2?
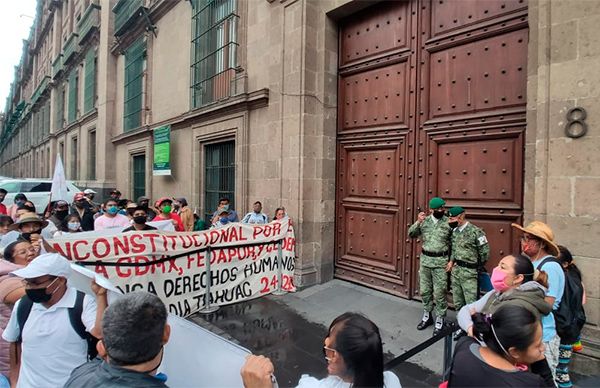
335;0;528;298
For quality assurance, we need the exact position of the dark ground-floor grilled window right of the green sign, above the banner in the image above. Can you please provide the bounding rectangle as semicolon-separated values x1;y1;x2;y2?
204;141;235;225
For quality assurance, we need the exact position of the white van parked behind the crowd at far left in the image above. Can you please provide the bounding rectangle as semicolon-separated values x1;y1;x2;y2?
0;178;82;214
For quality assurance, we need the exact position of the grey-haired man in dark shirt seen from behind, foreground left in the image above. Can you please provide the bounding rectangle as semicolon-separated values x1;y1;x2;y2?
65;292;171;388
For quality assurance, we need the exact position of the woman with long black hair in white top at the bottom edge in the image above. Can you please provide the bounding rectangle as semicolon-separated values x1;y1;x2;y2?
241;313;401;388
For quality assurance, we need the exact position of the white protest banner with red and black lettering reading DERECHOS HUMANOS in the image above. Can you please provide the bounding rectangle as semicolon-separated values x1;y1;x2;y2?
48;220;296;317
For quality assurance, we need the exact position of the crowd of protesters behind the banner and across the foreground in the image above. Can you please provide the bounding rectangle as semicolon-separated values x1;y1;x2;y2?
0;190;585;388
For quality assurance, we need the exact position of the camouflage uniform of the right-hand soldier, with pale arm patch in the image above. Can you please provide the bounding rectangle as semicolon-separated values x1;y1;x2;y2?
451;222;490;311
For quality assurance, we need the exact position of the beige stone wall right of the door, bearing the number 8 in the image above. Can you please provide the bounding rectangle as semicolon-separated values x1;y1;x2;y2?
525;0;600;338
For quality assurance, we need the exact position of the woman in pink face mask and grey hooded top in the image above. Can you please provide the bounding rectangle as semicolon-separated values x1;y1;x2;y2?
457;254;552;336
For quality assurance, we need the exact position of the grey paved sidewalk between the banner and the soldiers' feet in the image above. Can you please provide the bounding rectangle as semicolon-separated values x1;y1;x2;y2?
190;280;600;388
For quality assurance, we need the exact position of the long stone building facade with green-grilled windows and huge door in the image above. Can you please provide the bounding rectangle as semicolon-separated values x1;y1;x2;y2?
0;0;600;356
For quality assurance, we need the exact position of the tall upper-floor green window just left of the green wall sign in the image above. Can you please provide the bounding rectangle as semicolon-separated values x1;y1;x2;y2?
123;38;146;131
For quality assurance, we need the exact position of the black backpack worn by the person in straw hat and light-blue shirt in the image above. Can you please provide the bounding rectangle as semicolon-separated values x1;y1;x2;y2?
538;257;586;344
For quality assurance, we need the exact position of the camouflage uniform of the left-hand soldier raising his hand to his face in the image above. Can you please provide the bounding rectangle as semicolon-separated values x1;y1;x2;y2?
408;215;452;317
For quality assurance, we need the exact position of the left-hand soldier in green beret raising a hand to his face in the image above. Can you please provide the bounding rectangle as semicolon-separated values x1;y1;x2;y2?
408;197;452;335
